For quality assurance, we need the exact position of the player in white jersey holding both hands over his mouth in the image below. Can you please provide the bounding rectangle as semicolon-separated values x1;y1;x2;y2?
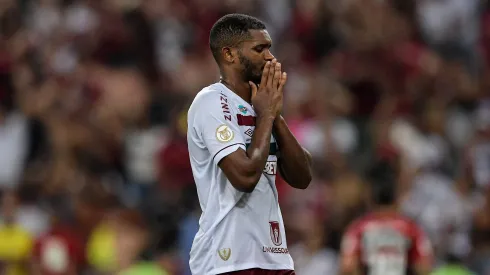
187;14;311;275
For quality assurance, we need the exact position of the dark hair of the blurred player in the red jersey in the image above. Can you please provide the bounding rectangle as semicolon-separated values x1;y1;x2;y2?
367;161;398;206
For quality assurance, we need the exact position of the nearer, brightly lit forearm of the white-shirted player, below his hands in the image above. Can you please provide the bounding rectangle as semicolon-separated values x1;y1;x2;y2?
247;115;274;183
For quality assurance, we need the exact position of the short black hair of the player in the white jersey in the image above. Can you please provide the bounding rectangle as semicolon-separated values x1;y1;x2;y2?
209;13;266;64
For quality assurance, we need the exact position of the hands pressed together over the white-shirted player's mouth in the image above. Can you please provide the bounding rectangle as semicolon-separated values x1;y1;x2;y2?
249;59;287;118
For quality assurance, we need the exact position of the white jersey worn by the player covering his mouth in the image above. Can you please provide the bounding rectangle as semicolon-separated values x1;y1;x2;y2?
187;83;294;275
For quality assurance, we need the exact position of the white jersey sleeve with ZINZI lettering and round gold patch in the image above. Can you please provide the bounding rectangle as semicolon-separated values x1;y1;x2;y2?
191;93;246;165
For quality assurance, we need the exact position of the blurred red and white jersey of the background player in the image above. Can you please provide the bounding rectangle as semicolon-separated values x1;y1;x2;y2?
341;214;432;275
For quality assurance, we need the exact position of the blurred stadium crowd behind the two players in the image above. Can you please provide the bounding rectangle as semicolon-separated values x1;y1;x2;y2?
0;0;490;275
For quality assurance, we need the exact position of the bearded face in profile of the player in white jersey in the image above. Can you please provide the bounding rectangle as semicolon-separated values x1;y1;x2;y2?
238;30;274;84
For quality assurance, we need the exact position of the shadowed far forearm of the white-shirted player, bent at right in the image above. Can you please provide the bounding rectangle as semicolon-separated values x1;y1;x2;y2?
273;116;311;189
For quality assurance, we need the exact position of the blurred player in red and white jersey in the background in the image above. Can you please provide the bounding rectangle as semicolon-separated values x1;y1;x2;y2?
340;163;433;275
